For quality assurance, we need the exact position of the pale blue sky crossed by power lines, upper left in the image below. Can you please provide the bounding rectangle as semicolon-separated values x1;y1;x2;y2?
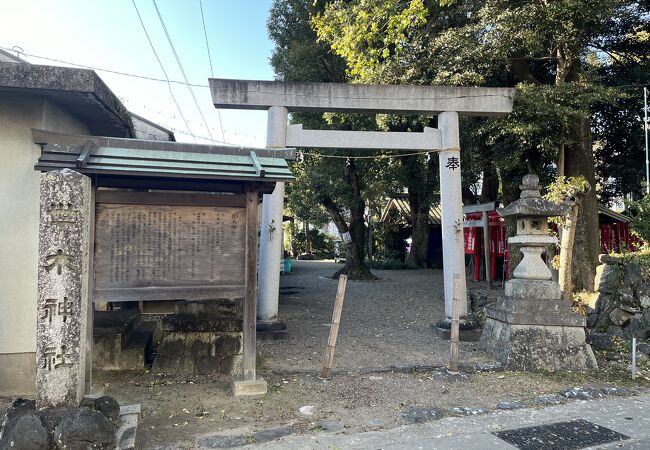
0;0;273;146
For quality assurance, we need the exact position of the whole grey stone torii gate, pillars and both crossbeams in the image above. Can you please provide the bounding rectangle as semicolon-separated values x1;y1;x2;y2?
210;79;514;330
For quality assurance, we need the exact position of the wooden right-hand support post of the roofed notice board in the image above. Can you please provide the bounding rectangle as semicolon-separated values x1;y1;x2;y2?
242;188;257;381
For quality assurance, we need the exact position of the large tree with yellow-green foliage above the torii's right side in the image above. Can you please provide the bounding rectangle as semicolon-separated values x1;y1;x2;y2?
314;0;648;288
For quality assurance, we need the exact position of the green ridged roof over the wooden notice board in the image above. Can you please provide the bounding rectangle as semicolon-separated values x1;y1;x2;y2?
32;130;294;182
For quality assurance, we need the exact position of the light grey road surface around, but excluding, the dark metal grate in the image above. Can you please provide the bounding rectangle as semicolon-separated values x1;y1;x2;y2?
245;393;650;450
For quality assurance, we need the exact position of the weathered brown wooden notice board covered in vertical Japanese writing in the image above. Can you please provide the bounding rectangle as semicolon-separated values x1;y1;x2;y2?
94;191;246;302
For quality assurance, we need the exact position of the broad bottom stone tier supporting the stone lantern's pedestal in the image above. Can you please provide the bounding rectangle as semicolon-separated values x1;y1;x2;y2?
480;317;598;371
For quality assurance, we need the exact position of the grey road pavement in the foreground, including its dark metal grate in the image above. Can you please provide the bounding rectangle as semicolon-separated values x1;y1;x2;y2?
244;393;650;450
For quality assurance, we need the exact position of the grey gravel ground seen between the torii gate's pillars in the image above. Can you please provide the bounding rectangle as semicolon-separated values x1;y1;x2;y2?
258;261;490;371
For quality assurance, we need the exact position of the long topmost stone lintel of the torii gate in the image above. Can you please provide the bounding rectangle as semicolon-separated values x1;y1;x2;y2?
210;78;514;116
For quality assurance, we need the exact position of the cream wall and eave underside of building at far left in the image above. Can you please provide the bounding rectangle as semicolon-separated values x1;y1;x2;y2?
0;93;89;396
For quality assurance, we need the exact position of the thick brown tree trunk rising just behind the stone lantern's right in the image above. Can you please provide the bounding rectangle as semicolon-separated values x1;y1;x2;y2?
564;117;600;291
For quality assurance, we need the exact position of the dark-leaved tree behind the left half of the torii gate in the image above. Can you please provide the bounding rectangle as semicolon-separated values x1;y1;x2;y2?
267;0;376;279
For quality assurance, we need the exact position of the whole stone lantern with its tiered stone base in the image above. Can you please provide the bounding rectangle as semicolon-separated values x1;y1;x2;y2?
480;175;596;370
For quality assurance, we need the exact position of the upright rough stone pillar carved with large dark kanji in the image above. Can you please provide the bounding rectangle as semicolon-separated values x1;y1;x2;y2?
36;169;91;408
